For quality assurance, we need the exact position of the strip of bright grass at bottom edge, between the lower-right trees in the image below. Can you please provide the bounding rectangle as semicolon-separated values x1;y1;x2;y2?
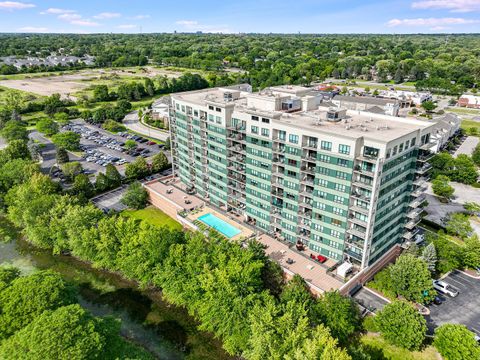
360;334;441;360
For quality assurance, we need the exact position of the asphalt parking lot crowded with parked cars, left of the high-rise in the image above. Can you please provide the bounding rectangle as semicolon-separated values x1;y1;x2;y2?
63;120;160;171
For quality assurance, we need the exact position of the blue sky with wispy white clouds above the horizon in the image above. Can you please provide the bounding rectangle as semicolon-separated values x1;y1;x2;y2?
0;0;480;34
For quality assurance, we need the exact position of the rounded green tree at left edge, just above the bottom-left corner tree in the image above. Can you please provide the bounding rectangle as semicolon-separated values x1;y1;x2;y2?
0;271;76;340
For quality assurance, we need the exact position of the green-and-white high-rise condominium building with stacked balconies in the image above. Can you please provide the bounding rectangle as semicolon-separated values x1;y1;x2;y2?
170;85;446;268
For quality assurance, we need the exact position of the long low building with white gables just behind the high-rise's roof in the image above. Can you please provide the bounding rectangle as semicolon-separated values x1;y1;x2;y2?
329;95;400;116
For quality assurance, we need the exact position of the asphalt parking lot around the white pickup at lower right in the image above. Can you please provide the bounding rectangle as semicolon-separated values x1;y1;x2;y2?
426;271;480;336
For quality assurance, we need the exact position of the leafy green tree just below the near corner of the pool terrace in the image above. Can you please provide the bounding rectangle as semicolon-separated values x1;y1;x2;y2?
316;291;361;344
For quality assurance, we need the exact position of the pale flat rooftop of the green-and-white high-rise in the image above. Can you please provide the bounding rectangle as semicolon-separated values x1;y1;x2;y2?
172;85;435;142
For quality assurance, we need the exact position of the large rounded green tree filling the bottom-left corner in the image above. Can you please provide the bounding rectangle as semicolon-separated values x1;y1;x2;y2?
0;304;107;360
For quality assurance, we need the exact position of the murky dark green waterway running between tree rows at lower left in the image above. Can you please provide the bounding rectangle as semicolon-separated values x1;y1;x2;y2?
0;218;232;360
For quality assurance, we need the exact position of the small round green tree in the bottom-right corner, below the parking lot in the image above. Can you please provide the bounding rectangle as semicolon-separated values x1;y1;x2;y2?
433;324;480;360
